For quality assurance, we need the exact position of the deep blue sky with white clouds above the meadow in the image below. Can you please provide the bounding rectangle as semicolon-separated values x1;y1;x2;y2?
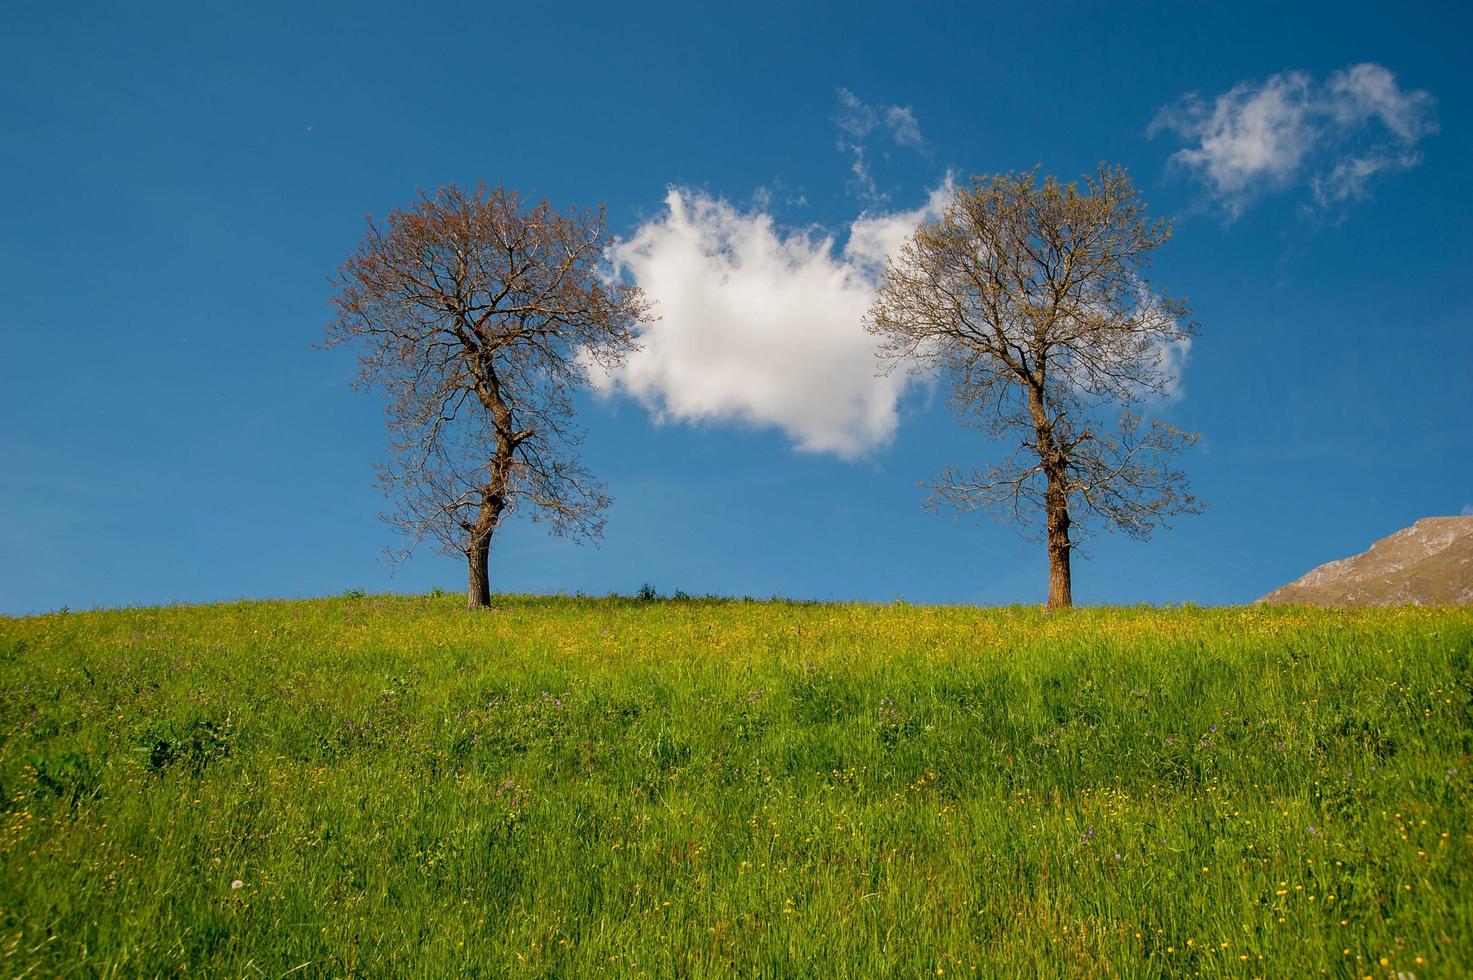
0;3;1473;613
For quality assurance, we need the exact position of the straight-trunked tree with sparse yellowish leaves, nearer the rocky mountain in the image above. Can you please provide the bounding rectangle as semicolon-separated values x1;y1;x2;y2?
868;165;1200;609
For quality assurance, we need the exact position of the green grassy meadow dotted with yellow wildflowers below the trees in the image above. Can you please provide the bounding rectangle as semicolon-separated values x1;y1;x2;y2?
0;595;1473;977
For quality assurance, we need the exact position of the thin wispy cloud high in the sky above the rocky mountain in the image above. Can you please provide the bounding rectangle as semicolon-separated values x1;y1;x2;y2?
1147;63;1438;217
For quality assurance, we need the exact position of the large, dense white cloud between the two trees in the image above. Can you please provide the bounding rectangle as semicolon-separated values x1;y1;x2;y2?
598;177;952;458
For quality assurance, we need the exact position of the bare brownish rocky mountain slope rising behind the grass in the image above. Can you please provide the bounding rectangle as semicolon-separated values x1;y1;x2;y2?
1258;517;1473;606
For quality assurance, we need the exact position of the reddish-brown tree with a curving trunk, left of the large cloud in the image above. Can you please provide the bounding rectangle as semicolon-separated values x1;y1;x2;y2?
327;184;650;609
